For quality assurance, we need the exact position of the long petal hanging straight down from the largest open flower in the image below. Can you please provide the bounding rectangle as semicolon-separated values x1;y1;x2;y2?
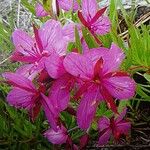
77;86;99;130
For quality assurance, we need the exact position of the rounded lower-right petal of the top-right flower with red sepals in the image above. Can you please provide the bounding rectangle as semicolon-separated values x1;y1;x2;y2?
91;16;111;35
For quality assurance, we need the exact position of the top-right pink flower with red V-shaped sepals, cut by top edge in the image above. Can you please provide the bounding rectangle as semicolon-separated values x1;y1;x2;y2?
78;0;110;43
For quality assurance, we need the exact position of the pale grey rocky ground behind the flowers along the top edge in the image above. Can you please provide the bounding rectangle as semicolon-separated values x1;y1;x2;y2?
0;0;150;30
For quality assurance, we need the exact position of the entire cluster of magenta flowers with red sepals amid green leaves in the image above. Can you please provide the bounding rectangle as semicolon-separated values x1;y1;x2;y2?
3;0;135;147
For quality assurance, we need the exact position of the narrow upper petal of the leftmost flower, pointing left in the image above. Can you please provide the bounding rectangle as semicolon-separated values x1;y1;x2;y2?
2;72;36;93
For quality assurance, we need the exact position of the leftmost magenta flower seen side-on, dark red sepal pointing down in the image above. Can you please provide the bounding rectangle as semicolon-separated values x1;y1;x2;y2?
3;73;45;121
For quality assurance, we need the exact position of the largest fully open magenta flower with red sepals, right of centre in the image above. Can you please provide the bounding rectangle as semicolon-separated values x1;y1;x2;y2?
64;44;135;129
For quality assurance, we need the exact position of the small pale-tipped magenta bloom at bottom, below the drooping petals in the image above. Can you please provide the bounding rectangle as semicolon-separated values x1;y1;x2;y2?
44;125;68;144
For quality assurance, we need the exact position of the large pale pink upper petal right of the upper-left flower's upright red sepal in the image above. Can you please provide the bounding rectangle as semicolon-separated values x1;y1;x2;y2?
39;20;67;55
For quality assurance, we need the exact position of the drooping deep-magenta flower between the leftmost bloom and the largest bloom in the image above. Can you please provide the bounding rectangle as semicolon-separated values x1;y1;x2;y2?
42;73;75;131
